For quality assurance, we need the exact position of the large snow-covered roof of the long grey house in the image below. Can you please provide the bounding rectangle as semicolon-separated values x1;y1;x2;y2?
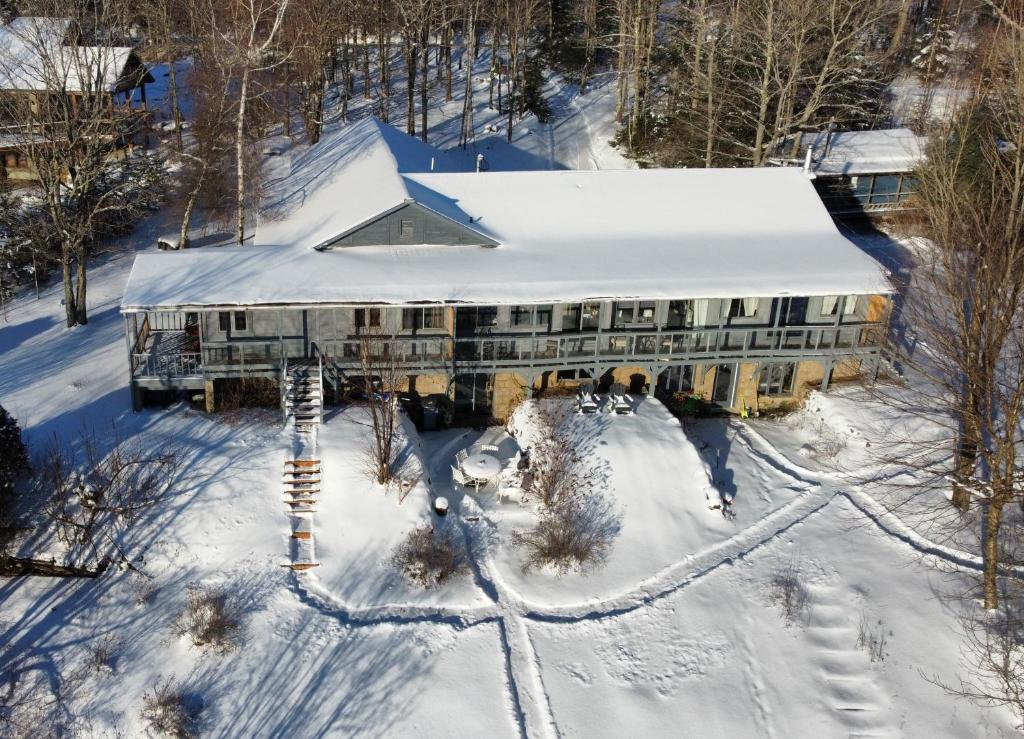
122;121;890;310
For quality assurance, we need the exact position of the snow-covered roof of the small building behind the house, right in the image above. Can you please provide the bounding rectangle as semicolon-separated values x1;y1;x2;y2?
811;128;928;176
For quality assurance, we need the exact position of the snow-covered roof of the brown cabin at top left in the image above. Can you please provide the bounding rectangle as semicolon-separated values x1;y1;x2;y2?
0;15;139;92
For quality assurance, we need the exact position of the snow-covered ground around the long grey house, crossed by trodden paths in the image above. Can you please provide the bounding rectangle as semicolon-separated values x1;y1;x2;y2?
0;51;1015;738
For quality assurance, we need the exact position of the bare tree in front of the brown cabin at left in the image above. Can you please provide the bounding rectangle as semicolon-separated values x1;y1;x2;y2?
0;5;154;327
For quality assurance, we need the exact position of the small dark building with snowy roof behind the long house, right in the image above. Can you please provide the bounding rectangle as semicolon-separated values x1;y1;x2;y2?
801;128;927;215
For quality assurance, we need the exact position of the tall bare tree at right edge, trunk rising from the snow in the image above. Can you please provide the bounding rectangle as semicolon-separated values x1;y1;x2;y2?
880;8;1024;609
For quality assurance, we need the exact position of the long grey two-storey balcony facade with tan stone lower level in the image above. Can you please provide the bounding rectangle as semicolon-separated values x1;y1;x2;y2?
132;295;889;419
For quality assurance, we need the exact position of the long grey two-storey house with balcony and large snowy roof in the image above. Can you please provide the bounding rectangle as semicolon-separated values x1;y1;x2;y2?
122;119;891;419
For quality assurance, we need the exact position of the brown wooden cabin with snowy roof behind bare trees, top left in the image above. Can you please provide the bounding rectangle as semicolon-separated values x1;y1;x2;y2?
0;16;154;180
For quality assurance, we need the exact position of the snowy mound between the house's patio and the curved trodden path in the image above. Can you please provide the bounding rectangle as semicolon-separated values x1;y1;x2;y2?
425;398;807;606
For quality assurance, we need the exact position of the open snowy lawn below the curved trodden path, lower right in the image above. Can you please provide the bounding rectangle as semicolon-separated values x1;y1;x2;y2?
530;489;1012;737
